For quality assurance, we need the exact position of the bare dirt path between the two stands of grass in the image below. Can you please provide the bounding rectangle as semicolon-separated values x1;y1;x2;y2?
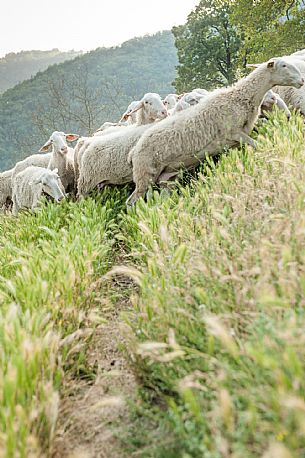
52;317;136;458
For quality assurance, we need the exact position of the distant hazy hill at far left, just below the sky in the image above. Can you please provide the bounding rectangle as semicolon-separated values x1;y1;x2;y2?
0;49;81;93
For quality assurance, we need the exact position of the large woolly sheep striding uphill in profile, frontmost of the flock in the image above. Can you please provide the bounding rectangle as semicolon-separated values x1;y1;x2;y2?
127;58;304;205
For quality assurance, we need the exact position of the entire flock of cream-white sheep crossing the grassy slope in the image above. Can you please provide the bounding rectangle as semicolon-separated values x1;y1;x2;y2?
0;49;305;215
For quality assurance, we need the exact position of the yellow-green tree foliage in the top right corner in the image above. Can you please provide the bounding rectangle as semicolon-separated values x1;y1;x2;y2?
232;0;305;62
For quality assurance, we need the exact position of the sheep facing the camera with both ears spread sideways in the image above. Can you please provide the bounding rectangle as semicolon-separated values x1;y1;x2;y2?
39;131;79;192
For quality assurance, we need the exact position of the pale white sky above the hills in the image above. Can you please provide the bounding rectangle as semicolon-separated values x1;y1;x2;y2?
0;0;199;57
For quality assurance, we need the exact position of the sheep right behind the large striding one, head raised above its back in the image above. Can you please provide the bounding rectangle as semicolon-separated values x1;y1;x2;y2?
74;93;167;196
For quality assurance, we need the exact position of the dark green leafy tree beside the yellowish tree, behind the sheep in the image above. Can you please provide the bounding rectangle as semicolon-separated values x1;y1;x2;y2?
173;0;242;92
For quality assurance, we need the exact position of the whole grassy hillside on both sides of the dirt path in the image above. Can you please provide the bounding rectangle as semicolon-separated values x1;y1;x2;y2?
0;115;305;458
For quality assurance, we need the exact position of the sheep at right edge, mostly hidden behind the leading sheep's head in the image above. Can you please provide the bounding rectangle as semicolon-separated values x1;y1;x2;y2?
274;54;305;116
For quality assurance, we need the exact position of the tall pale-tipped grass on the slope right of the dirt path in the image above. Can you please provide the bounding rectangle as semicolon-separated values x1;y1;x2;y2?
121;112;305;458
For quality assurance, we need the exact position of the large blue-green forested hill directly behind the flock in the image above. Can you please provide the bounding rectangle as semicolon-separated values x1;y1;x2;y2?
0;31;178;170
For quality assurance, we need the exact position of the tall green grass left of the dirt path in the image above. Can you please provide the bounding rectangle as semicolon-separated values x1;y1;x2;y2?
0;191;124;458
